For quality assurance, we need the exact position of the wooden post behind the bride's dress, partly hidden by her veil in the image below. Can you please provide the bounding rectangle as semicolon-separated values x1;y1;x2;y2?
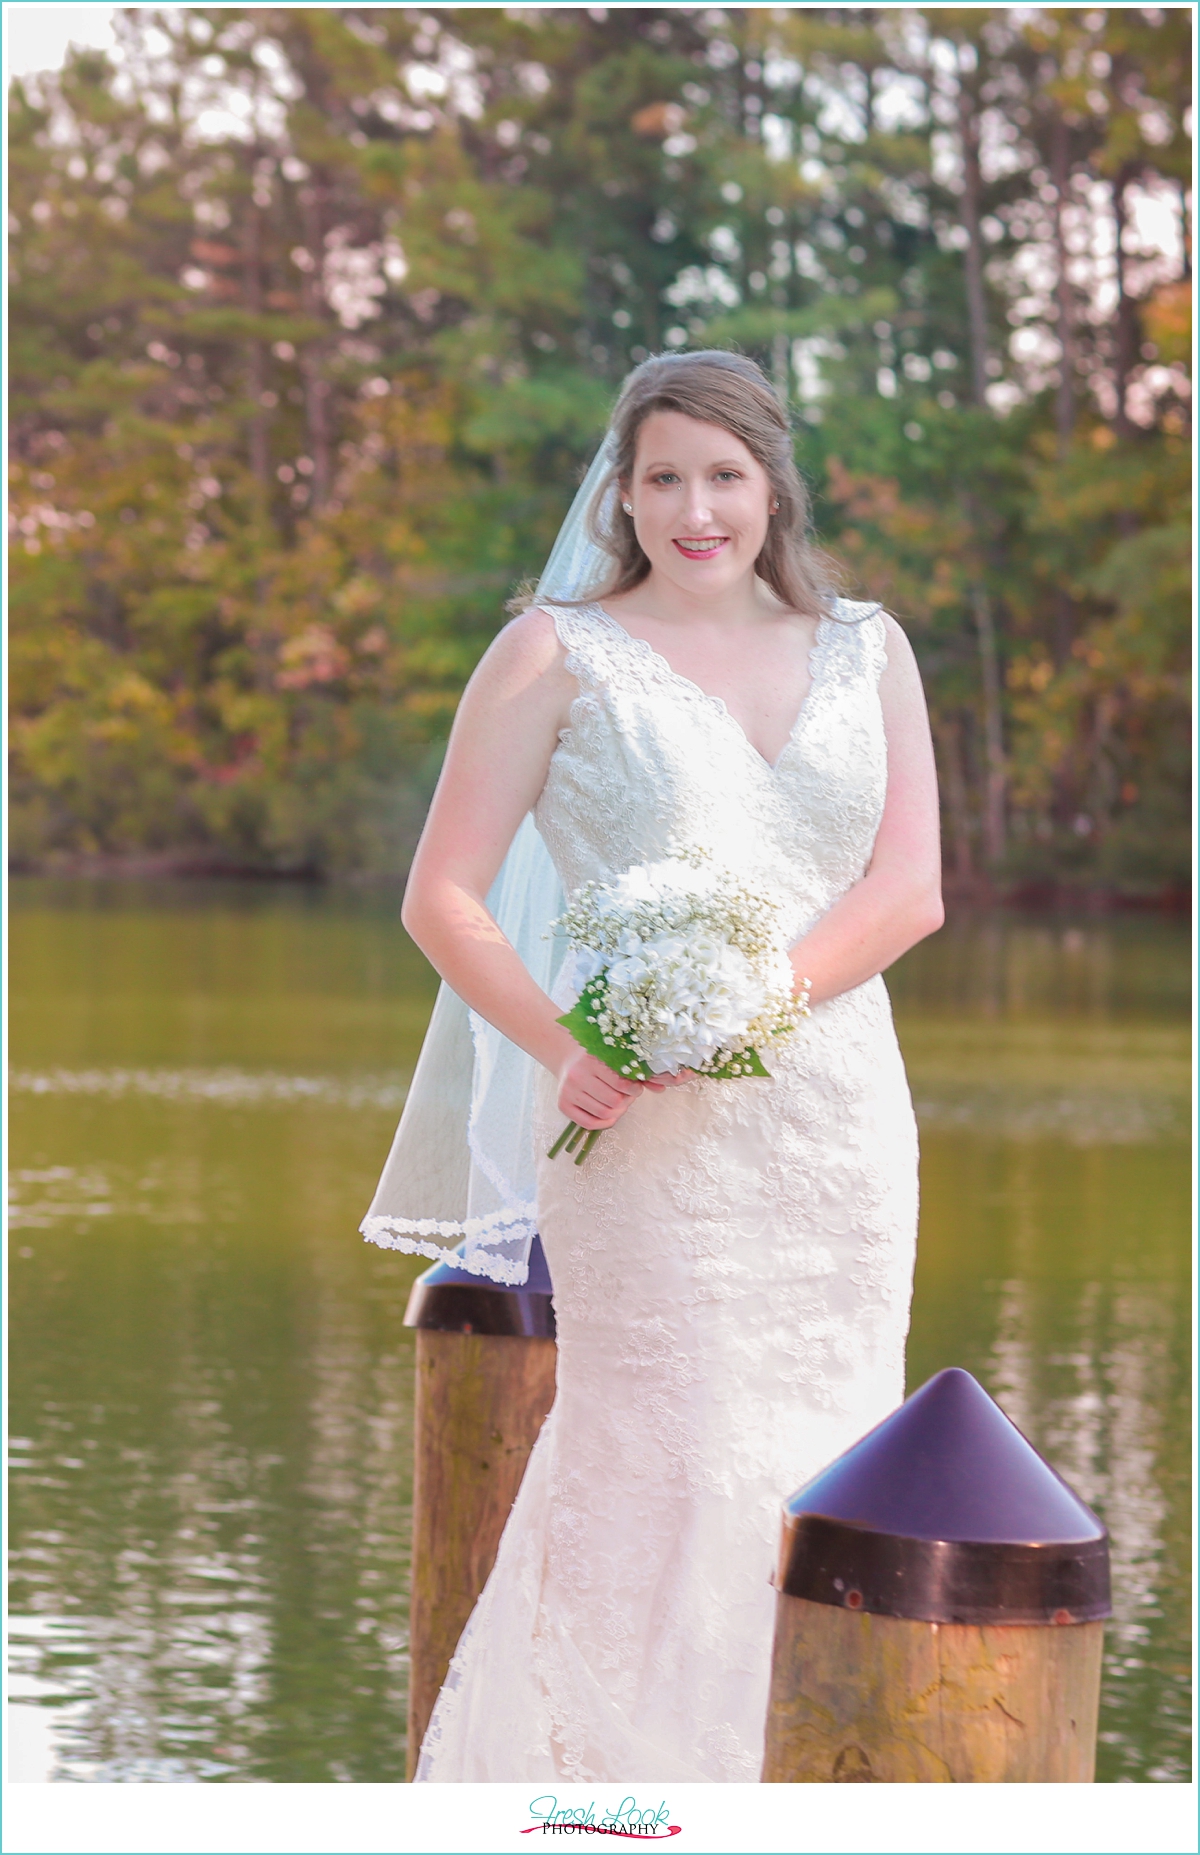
404;1237;555;1781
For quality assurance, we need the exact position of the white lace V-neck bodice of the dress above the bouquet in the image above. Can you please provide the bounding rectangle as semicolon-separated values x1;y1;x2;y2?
534;599;887;939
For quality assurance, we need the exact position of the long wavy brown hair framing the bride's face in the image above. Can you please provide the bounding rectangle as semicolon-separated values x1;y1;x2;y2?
588;349;835;616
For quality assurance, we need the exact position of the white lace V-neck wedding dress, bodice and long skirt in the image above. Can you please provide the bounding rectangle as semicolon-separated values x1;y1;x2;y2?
417;601;916;1783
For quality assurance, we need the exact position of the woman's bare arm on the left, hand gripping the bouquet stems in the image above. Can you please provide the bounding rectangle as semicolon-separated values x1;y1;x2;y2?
401;610;642;1128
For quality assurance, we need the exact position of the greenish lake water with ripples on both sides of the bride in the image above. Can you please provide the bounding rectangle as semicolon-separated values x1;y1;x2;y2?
9;879;1191;1783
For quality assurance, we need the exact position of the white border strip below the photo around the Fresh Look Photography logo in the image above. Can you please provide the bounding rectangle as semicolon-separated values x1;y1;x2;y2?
0;0;1200;1855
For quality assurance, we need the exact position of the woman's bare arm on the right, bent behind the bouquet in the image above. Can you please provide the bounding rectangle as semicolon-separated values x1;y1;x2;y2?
792;618;944;1002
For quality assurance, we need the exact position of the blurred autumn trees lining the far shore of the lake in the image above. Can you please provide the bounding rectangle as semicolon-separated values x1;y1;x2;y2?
9;6;1193;894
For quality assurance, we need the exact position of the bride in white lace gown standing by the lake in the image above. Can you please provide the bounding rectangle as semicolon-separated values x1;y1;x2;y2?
364;352;942;1783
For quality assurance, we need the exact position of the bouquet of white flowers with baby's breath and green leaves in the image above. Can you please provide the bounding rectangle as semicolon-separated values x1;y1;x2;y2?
549;850;811;1165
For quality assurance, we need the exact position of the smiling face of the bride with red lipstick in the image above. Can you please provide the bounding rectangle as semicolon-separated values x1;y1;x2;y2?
621;412;773;594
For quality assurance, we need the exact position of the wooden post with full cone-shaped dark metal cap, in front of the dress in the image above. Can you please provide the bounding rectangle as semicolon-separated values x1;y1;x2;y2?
762;1367;1111;1785
